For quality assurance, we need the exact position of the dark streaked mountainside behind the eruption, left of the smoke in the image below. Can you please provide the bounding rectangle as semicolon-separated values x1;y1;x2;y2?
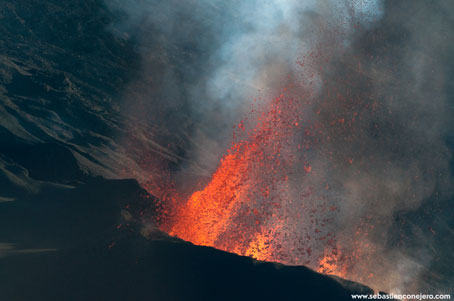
0;0;153;184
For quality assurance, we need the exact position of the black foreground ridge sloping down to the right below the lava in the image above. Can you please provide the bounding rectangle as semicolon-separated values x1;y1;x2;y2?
0;179;371;301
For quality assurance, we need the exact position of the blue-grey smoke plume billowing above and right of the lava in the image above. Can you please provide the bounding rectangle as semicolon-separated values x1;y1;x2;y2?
106;0;454;293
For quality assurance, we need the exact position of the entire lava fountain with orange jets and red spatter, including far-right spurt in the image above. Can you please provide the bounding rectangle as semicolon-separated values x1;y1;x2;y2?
161;74;373;280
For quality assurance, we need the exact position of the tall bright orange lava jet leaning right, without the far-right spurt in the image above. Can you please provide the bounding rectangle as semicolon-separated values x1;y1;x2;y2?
165;95;298;260
